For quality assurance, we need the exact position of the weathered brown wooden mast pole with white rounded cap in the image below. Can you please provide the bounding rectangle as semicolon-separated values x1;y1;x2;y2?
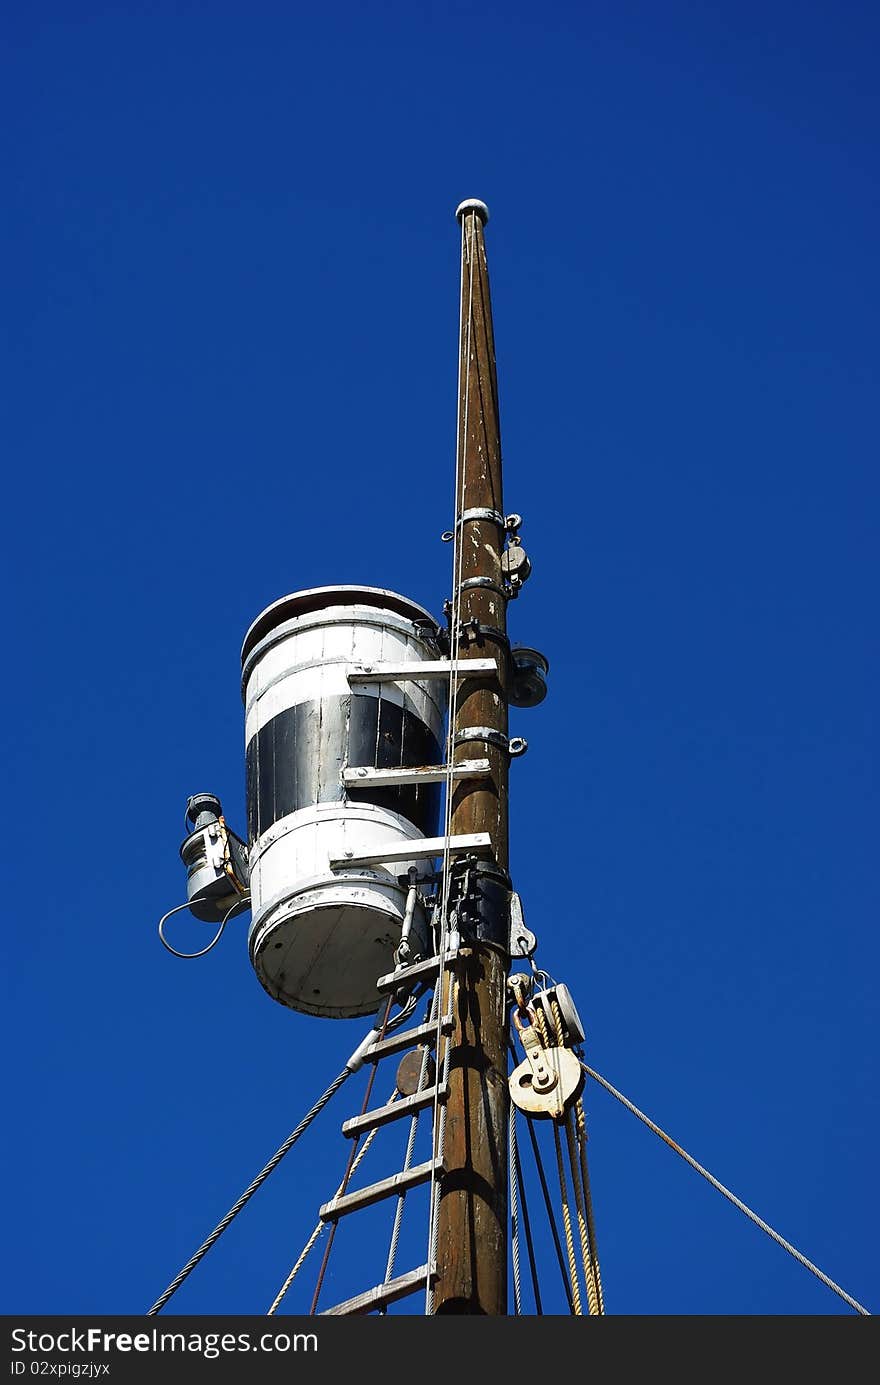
434;199;509;1314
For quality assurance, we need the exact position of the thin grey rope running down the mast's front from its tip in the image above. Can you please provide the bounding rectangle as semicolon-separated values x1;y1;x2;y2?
425;202;477;1316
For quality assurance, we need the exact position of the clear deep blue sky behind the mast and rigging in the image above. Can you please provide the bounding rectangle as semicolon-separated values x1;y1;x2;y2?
0;0;880;1316
